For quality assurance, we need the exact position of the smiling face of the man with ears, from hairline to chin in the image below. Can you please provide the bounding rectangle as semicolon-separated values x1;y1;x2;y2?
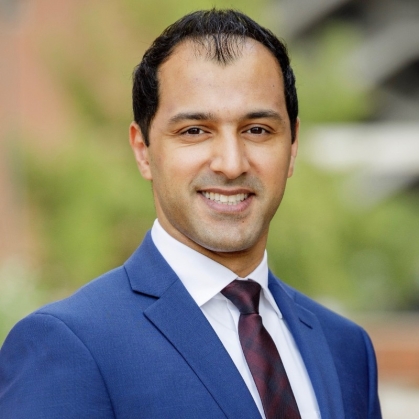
130;39;297;264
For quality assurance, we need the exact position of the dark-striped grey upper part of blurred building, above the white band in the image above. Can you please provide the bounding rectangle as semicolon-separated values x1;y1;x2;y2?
280;0;419;122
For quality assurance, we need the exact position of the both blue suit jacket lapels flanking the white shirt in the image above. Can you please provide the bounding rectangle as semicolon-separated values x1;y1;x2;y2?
124;233;345;419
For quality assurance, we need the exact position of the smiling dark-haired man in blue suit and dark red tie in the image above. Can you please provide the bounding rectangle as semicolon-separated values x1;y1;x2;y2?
0;10;381;419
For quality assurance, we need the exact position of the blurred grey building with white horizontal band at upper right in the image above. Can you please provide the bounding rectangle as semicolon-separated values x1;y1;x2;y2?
278;0;419;204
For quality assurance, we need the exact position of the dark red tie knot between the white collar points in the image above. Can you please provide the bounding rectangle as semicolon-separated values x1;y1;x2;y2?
221;279;261;314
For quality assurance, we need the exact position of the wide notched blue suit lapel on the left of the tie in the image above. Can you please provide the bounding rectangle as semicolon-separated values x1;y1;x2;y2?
125;234;260;419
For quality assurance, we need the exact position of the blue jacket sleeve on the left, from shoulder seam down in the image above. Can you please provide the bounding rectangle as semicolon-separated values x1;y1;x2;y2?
0;313;115;419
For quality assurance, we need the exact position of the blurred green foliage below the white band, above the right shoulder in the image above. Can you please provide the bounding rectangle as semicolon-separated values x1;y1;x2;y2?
268;161;419;311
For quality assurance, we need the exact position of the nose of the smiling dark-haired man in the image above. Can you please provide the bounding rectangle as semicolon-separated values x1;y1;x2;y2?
210;133;250;179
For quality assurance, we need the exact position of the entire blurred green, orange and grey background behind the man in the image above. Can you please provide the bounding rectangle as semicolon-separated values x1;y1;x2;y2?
0;0;419;419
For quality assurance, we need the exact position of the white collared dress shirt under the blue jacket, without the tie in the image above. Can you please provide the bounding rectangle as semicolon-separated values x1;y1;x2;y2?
151;220;320;419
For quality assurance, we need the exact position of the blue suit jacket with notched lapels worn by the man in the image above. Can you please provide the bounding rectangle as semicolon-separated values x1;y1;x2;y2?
0;234;381;419
